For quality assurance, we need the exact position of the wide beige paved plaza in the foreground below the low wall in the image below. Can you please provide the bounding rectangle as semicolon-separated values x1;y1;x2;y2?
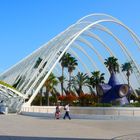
0;114;140;140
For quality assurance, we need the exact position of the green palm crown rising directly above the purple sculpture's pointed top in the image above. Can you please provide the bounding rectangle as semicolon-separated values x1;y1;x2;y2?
104;56;119;74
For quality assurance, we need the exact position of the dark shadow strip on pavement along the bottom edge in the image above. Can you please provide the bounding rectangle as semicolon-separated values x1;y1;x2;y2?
0;136;108;140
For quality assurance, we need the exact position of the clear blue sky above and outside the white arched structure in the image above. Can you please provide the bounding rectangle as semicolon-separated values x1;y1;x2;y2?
0;0;140;73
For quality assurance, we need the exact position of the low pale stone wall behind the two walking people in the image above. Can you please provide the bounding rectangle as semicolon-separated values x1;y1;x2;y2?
21;106;140;117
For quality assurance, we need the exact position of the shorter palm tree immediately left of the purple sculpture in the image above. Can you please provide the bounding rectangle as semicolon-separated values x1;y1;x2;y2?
89;71;105;93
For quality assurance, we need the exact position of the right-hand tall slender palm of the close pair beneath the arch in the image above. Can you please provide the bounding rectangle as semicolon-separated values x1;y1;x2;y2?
67;56;78;92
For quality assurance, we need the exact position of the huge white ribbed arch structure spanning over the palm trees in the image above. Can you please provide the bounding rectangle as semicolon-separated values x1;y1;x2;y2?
0;13;140;105
